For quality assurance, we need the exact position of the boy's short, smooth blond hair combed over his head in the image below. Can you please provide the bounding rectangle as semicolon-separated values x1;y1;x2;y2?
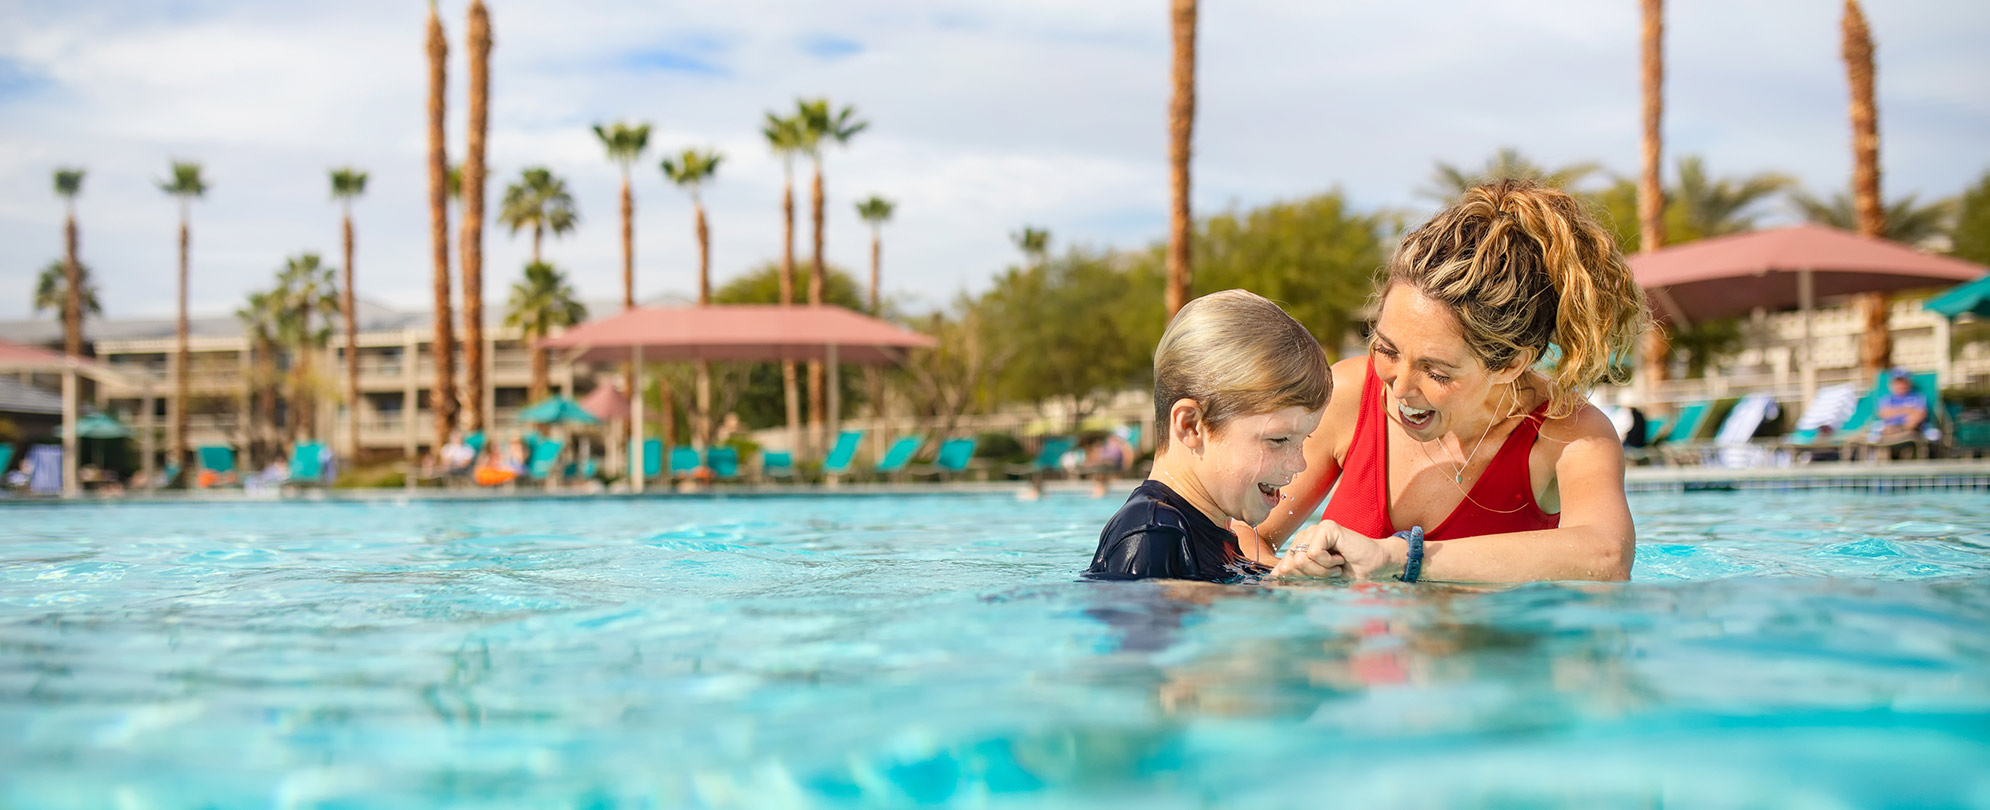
1154;291;1333;448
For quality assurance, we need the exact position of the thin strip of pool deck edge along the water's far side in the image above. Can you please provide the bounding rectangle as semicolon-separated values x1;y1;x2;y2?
0;460;1990;506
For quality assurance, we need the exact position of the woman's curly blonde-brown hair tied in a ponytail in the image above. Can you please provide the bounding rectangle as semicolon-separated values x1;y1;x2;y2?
1381;179;1652;418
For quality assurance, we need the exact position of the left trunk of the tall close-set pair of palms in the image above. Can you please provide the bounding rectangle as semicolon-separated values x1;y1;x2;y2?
423;0;456;450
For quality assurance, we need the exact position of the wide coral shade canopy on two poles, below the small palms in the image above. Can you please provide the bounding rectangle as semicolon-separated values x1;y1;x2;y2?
539;304;935;492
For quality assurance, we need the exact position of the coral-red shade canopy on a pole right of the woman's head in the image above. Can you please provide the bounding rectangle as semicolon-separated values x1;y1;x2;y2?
1630;225;1986;402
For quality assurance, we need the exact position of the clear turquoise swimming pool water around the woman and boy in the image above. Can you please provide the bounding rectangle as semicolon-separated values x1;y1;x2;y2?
0;492;1990;808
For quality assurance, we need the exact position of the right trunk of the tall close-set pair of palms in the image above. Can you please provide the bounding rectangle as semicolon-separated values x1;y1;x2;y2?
462;0;492;437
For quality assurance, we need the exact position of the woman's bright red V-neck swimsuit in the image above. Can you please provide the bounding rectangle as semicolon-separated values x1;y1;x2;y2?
1321;358;1562;539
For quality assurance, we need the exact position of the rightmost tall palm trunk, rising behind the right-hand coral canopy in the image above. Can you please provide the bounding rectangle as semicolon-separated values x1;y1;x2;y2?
1843;0;1892;376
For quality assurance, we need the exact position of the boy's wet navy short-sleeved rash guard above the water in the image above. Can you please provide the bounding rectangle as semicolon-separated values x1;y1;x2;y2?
1085;482;1270;581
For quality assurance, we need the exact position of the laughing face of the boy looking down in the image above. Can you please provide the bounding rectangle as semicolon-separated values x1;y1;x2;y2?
1196;406;1325;523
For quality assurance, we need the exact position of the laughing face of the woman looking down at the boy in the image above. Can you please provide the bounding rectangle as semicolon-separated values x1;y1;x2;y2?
1369;285;1522;442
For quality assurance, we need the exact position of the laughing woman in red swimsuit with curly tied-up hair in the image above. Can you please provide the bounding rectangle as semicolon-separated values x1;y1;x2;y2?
1240;181;1650;581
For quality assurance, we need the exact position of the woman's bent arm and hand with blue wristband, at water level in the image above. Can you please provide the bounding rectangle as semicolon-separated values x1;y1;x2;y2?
1272;410;1638;581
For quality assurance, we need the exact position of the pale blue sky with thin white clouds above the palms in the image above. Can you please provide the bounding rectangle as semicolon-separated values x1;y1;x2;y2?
0;0;1990;318
